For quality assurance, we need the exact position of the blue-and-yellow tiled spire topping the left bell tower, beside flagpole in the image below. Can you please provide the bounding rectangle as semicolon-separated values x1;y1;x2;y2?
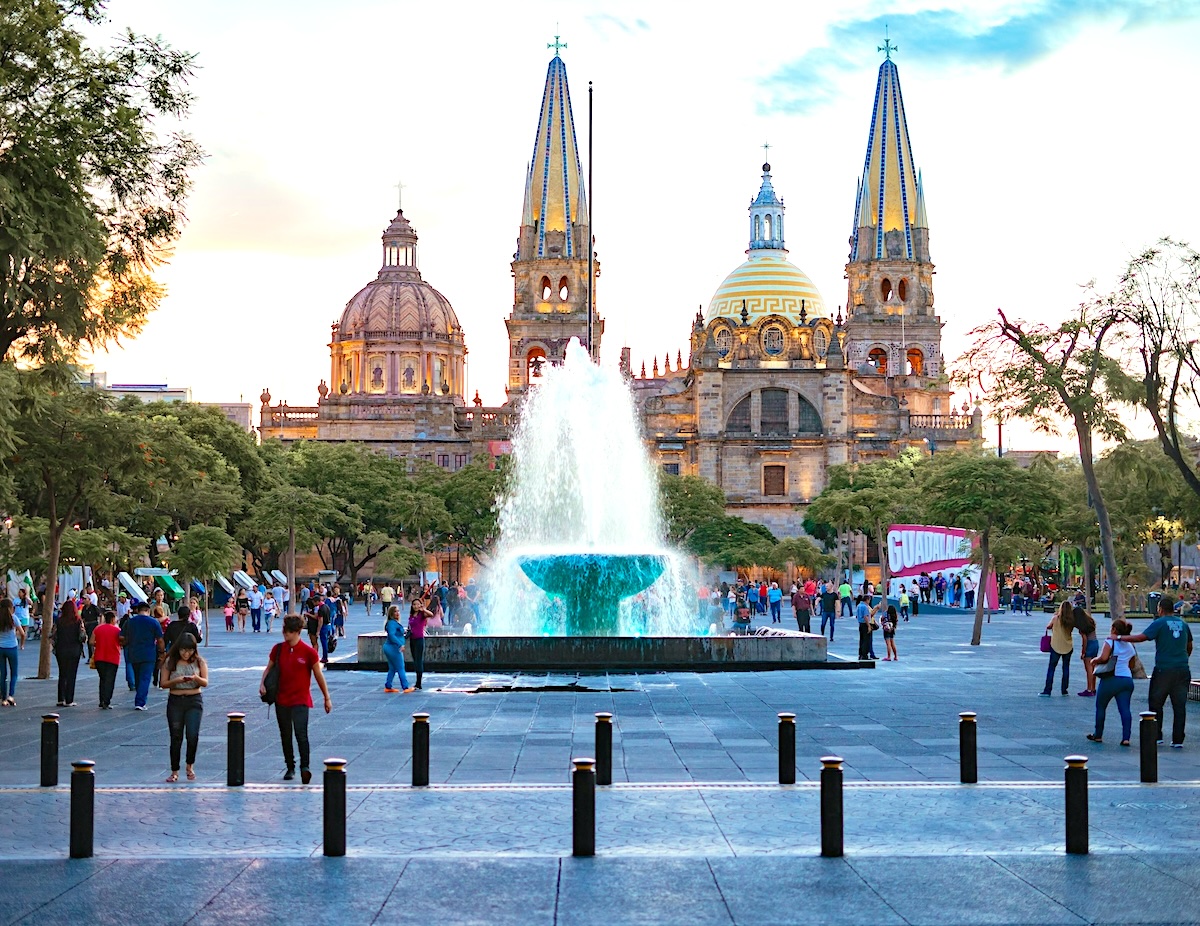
521;50;588;258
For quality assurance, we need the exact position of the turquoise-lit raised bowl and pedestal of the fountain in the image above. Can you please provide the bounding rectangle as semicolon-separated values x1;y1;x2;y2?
516;551;667;637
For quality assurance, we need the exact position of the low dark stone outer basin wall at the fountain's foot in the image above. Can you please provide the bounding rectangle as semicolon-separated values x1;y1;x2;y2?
350;631;844;672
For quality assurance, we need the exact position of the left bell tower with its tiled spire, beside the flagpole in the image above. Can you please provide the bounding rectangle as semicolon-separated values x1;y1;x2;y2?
504;47;604;397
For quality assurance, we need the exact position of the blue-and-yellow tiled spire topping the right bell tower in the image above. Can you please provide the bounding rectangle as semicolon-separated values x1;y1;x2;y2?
850;49;929;260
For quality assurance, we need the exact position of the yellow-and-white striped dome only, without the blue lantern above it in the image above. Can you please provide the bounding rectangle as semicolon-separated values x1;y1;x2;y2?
704;249;829;324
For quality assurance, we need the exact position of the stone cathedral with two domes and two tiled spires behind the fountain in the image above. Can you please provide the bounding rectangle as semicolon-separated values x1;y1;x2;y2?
260;49;982;537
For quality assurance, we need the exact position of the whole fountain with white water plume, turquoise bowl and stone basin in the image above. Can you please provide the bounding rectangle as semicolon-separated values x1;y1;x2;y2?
359;341;834;671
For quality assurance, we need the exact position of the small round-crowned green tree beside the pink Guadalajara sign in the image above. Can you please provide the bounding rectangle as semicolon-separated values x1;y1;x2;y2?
922;453;1058;647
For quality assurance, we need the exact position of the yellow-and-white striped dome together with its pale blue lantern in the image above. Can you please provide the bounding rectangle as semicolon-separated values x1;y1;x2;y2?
704;164;828;324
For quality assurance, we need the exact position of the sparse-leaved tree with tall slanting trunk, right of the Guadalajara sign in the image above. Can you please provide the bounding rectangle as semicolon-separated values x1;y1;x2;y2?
960;299;1127;618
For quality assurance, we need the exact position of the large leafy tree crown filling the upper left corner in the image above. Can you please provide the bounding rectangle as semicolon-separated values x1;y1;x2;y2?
0;0;202;362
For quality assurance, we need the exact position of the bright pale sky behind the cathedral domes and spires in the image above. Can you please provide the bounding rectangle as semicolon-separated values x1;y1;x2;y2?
92;0;1200;449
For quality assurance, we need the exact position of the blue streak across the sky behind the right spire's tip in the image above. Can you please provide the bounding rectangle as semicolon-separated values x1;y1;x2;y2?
762;0;1200;113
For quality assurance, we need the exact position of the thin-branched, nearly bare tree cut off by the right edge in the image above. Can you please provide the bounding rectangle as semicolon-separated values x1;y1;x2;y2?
1105;237;1200;495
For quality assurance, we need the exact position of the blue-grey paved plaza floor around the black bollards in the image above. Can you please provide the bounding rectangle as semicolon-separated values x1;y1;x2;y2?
0;608;1200;926
